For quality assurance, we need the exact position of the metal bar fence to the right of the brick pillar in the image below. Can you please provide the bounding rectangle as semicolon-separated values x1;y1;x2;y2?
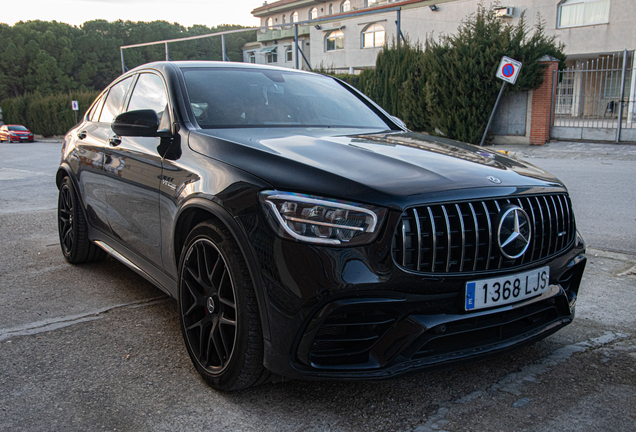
552;50;636;141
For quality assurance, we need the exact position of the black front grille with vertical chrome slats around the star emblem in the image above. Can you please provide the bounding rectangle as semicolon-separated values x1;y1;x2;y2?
393;194;576;273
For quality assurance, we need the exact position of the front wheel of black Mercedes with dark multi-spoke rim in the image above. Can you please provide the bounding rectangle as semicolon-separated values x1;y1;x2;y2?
178;221;270;390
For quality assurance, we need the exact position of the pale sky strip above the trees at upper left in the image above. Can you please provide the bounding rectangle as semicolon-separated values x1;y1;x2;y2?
0;0;263;27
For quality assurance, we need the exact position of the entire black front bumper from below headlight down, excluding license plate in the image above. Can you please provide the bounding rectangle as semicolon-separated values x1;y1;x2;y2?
246;207;586;380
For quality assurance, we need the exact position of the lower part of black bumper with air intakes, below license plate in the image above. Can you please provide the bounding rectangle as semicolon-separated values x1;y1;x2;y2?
266;246;586;380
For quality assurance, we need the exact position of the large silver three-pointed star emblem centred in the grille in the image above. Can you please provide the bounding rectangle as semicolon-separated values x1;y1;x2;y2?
497;205;532;259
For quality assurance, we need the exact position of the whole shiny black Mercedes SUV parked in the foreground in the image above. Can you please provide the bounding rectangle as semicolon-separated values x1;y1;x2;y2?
56;62;586;390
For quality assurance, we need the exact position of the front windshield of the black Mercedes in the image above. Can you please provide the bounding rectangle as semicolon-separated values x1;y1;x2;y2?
183;68;391;130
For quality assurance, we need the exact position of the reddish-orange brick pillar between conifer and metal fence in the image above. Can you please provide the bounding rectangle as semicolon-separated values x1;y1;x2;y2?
522;56;559;145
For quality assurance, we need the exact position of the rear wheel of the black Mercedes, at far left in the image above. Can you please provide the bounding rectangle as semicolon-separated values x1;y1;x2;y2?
57;177;106;264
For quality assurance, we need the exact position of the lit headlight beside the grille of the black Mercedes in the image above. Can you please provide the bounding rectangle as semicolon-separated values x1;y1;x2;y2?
259;191;387;246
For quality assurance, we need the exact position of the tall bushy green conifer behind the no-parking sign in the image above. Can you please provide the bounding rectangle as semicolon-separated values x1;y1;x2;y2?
422;4;565;144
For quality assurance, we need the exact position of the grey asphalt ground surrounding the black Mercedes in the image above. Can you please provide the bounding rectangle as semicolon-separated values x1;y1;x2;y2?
0;143;636;432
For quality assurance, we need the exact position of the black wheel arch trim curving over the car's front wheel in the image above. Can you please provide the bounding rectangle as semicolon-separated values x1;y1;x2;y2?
172;197;270;340
